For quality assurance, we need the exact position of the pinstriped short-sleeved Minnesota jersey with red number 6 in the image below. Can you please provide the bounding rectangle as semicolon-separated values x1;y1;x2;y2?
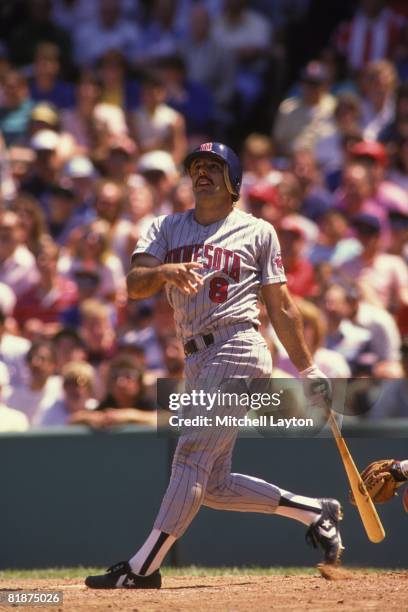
133;209;286;341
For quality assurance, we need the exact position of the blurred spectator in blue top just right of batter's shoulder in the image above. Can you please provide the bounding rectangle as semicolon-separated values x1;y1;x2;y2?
291;149;333;222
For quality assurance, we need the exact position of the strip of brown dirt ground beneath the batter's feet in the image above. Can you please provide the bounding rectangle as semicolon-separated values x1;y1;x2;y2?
0;570;408;612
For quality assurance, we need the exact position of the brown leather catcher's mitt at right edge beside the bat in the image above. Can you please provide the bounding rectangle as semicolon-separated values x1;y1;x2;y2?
350;459;407;504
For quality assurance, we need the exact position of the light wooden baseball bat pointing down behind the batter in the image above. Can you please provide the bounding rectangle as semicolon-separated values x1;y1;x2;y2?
329;410;385;544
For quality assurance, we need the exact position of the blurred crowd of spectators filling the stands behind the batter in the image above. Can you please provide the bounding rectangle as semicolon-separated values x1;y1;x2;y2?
0;0;408;431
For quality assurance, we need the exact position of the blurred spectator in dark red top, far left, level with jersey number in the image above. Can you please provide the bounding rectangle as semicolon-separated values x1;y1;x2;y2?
13;235;78;337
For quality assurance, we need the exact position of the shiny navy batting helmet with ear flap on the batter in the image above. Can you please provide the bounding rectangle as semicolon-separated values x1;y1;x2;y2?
184;142;242;202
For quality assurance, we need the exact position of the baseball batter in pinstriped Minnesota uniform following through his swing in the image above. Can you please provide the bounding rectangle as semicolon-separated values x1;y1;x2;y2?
85;142;343;589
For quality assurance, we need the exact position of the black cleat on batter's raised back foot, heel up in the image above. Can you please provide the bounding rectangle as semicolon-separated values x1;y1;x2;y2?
306;499;344;565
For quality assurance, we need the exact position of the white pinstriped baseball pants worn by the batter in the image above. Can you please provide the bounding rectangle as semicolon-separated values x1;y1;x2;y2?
154;328;281;538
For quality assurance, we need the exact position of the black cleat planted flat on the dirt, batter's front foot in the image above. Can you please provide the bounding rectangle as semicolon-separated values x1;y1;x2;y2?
85;561;161;589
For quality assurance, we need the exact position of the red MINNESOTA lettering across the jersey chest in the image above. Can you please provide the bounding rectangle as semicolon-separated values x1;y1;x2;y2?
165;244;241;283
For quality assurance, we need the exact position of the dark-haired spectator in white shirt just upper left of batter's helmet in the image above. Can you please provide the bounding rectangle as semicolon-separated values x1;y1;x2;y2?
130;72;187;164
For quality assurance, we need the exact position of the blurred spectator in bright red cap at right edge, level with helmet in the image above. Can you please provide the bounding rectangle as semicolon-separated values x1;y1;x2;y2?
349;141;408;213
